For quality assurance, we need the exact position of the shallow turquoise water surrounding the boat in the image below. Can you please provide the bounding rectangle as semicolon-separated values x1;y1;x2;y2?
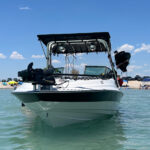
0;90;150;150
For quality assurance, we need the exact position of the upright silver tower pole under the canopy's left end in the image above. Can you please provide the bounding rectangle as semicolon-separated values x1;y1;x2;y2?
47;42;54;68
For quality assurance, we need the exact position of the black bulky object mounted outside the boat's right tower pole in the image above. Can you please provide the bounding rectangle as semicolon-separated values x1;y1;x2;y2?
114;51;131;72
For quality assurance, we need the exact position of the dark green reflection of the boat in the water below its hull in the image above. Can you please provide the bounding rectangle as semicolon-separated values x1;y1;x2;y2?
16;108;126;150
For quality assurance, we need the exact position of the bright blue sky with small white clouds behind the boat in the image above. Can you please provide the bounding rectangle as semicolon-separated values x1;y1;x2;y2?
0;0;150;79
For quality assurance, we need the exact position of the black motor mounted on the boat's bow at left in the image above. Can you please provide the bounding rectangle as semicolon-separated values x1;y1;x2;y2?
18;63;55;85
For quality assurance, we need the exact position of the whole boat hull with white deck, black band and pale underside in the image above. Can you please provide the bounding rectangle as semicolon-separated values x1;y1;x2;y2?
13;79;123;127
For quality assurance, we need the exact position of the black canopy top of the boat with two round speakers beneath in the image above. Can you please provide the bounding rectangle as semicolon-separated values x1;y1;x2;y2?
37;32;111;54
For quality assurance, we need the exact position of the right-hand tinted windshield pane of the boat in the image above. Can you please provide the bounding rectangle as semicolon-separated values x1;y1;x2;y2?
84;66;111;75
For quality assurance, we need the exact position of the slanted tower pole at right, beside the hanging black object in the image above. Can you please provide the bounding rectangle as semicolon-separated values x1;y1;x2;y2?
108;48;120;87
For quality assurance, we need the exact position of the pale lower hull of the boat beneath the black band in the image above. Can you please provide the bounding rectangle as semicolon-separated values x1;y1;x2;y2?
25;101;118;127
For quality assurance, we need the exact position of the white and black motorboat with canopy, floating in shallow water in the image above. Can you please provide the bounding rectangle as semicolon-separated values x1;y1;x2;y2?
12;32;128;127
